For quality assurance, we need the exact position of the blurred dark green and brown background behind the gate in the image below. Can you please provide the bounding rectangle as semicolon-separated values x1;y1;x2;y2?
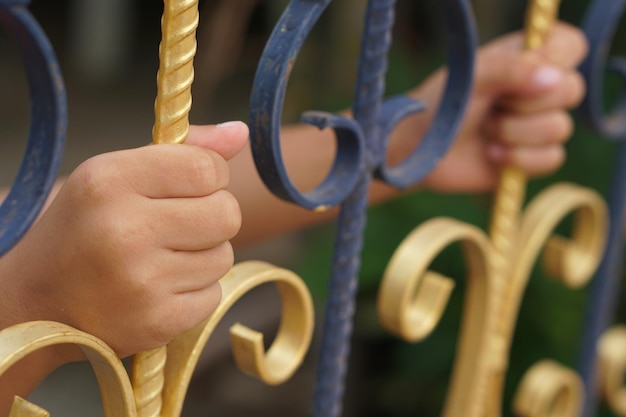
0;0;626;417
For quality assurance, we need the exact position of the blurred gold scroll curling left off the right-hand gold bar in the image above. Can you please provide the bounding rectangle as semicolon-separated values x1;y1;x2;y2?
378;218;494;416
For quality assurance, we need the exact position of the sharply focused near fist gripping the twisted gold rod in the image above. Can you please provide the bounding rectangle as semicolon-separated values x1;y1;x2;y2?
0;123;248;356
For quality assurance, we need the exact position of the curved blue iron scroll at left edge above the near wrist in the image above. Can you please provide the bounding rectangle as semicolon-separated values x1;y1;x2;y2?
0;0;67;256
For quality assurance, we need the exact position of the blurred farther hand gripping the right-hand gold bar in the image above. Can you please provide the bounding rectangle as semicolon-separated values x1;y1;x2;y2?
414;24;587;192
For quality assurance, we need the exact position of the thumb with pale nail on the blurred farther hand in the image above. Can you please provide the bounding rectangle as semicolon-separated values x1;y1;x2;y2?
475;48;565;97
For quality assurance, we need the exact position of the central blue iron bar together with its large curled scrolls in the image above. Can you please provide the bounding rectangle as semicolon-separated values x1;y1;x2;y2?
250;0;477;417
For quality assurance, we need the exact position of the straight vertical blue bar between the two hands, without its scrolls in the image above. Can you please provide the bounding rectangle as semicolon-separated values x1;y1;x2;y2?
313;0;395;417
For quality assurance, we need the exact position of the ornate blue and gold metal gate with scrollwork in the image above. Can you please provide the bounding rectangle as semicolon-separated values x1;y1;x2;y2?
0;0;626;417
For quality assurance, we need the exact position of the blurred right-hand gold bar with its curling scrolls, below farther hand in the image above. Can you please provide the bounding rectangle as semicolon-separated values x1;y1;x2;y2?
378;0;608;417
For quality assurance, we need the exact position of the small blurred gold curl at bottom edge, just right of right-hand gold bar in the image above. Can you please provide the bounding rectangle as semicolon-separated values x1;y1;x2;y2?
513;360;584;417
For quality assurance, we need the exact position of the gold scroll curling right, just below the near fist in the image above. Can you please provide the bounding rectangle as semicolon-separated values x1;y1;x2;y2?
161;261;314;417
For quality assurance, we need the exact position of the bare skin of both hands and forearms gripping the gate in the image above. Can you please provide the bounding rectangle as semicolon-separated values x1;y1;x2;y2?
0;24;587;414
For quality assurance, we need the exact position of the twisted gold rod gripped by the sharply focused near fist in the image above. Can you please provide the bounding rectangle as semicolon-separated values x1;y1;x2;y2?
132;0;199;417
